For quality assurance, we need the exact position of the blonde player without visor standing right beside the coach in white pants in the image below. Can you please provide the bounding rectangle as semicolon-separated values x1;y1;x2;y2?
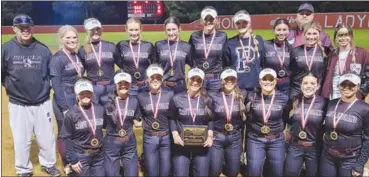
49;25;84;171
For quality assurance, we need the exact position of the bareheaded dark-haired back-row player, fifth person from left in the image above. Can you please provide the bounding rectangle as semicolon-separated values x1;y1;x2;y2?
155;17;192;93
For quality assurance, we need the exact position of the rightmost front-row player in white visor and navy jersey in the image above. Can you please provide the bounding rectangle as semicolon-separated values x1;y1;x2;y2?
320;73;369;177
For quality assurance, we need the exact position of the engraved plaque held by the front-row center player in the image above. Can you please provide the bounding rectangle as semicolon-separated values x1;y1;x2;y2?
181;125;208;146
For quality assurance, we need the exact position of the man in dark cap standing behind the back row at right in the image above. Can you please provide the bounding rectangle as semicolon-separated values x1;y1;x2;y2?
288;3;333;51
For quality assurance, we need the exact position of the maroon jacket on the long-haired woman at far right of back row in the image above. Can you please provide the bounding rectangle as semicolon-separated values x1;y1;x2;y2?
321;47;369;99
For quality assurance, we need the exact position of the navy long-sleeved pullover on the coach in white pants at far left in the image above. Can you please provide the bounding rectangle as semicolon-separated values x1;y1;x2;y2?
1;37;51;105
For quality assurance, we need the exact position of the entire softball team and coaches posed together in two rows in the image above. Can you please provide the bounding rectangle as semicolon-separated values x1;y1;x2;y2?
1;3;369;177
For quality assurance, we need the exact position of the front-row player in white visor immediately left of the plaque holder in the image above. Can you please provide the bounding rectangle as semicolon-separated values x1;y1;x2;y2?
136;64;173;176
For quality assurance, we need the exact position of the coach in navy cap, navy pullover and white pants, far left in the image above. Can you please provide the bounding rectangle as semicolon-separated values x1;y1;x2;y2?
1;14;60;176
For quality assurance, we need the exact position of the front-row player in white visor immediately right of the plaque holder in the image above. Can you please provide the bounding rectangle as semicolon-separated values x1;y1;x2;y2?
209;69;246;177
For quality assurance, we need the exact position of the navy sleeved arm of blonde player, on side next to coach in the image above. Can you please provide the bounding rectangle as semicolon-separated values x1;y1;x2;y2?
49;56;68;112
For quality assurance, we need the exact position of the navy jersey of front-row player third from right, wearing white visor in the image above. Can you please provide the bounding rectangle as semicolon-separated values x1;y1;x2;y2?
246;91;288;135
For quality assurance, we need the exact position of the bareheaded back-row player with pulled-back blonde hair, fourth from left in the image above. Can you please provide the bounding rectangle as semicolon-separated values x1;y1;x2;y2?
117;18;155;96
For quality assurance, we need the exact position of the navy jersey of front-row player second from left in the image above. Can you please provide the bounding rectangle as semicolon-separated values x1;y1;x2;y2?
104;93;138;136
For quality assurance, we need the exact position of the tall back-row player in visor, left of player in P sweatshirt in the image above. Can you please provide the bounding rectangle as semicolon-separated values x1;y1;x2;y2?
189;6;229;92
